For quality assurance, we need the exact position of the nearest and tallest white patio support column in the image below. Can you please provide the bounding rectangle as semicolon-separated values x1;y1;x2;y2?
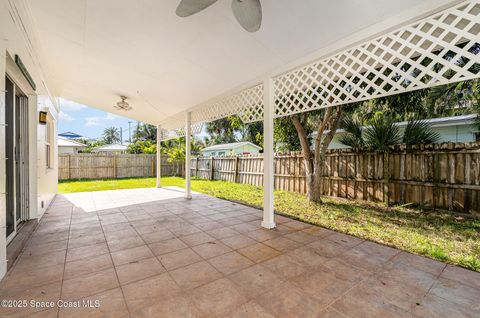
262;78;275;229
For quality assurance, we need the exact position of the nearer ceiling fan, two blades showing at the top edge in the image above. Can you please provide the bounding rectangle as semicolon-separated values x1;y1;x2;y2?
176;0;262;32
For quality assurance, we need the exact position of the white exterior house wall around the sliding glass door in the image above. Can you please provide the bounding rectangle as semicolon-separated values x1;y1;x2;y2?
0;0;58;278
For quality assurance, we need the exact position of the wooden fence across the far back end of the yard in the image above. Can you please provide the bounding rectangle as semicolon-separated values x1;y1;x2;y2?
58;154;185;180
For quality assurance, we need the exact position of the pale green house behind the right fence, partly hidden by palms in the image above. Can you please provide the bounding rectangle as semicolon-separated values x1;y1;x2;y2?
325;114;480;149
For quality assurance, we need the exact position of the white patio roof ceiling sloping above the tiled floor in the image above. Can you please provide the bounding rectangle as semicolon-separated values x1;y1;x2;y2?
27;0;458;124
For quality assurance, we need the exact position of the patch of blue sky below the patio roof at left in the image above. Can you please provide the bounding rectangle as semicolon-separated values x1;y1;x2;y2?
58;99;141;140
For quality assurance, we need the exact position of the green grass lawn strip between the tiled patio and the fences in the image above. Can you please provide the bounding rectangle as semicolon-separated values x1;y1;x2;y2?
59;177;480;271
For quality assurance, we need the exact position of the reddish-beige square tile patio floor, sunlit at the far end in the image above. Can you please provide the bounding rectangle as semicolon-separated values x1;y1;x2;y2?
0;189;480;318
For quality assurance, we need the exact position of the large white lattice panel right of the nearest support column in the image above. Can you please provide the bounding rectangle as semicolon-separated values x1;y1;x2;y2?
274;0;480;117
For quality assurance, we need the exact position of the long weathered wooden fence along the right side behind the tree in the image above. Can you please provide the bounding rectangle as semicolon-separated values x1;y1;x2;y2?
191;143;480;215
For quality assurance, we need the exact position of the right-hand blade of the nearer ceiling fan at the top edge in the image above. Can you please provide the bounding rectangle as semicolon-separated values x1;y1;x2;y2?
232;0;262;32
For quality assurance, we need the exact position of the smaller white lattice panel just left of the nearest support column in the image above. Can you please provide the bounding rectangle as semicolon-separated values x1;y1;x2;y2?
192;84;263;122
